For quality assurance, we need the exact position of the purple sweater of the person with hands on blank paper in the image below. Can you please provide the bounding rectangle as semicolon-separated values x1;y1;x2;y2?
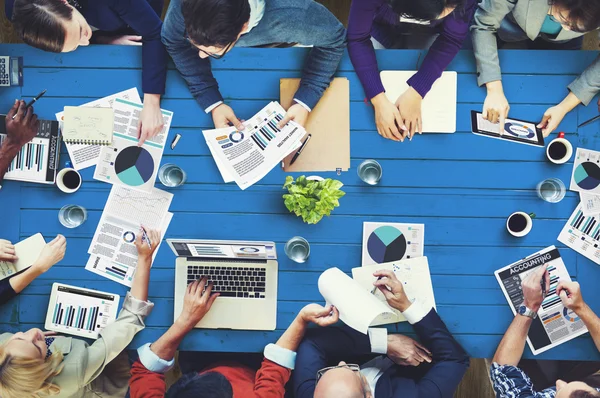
348;0;477;99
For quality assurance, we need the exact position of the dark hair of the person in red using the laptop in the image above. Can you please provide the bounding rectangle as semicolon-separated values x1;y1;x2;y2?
165;372;233;398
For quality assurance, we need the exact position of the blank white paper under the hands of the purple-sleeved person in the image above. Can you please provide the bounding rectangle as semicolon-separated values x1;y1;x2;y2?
380;70;457;133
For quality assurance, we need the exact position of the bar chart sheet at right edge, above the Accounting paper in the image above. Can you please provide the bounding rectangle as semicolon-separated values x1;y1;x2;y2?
558;203;600;264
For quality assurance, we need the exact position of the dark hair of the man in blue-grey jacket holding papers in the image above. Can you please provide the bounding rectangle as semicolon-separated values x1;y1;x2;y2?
181;0;250;47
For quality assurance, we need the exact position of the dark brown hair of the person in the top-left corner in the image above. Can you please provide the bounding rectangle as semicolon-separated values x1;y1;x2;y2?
12;0;73;53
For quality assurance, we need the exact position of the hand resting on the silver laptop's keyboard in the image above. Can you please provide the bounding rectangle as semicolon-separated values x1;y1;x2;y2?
177;277;219;330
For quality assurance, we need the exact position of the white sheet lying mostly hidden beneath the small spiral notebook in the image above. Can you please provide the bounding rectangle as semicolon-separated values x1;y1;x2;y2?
56;87;142;170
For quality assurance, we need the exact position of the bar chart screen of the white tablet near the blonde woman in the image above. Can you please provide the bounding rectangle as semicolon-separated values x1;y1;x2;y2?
52;286;118;336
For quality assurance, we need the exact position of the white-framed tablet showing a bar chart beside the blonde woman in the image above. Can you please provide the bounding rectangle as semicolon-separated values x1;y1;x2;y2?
45;283;120;339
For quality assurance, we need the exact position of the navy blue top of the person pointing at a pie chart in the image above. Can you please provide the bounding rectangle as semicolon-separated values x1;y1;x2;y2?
5;0;168;94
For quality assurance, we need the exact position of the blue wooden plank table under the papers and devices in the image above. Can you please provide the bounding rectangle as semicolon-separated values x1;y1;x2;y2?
0;45;600;360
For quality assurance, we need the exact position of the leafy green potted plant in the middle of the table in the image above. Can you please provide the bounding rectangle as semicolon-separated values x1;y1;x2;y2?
283;176;346;224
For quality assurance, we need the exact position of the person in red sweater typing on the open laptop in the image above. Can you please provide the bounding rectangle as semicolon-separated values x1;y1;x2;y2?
129;277;339;398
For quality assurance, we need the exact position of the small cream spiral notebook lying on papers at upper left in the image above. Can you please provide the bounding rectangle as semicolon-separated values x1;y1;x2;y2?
62;106;114;145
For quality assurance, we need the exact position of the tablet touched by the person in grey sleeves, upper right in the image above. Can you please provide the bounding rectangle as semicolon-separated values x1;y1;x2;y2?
471;111;544;147
